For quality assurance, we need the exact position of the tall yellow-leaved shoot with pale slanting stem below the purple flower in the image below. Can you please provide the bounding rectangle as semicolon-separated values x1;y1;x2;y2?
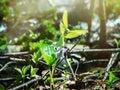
57;11;88;79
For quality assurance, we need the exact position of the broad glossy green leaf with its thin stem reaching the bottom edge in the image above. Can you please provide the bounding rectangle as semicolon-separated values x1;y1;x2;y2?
40;40;57;90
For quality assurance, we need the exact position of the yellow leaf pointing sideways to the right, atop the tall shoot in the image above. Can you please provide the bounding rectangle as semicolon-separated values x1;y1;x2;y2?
65;30;88;39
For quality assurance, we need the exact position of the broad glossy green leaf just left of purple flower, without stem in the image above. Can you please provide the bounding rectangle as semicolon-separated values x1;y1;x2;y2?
40;43;56;66
